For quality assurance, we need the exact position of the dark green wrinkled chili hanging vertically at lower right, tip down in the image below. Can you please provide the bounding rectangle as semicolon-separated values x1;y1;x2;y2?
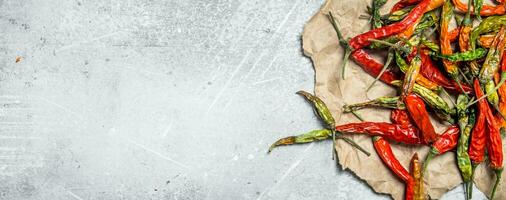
457;95;474;190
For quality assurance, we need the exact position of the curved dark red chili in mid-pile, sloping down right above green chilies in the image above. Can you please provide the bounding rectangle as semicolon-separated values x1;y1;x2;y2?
420;49;473;93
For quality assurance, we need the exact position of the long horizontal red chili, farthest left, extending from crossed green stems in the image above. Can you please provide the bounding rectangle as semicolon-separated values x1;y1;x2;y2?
336;122;426;144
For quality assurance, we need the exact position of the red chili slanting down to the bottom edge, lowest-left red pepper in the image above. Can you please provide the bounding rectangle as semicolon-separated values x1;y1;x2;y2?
373;137;415;200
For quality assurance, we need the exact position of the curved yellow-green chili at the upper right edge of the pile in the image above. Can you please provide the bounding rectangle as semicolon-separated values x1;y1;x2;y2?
469;15;506;49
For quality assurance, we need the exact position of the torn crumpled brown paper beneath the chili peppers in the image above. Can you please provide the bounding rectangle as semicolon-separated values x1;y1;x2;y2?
303;0;506;199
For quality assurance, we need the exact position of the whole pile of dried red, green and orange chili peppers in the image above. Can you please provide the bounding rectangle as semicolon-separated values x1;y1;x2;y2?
269;0;506;199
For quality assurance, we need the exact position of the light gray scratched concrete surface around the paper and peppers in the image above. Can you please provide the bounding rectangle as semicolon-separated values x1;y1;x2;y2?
0;0;483;200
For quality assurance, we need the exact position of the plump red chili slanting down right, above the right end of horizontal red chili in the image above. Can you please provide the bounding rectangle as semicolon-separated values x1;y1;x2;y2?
404;94;438;143
